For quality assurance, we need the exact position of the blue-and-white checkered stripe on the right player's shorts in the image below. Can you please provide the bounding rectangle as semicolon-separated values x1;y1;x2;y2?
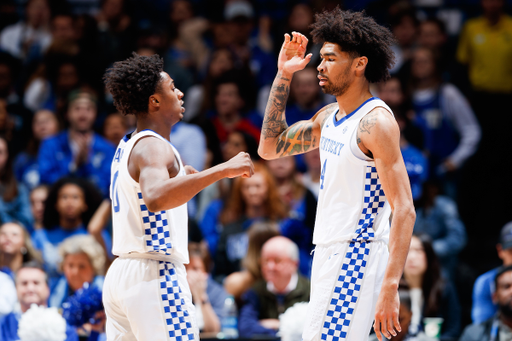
321;242;370;341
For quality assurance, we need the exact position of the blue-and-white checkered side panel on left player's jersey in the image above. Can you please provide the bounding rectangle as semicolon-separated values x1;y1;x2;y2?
138;192;172;255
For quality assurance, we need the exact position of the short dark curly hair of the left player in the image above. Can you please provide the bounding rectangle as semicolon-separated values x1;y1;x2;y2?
103;52;164;116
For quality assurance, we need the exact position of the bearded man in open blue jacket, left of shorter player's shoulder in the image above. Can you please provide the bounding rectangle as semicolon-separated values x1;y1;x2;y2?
38;92;115;197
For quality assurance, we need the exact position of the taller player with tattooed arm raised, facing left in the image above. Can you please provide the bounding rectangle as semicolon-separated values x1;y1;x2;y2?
259;8;415;341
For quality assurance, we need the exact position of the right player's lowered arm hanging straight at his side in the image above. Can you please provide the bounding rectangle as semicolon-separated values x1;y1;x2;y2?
357;108;416;341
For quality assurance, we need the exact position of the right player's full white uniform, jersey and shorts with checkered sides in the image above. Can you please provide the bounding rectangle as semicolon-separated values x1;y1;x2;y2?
303;97;391;341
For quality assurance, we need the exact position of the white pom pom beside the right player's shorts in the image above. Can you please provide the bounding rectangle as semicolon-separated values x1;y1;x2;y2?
278;302;309;341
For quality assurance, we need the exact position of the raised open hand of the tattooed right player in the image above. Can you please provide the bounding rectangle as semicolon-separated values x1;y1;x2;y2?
277;32;313;73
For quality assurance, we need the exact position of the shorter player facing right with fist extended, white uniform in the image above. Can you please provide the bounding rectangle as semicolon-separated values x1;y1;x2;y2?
103;54;253;341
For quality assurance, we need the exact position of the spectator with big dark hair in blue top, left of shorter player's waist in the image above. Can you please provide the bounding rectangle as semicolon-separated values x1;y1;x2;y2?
33;178;106;284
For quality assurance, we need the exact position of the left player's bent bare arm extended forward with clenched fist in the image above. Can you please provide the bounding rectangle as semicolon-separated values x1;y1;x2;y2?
129;137;254;212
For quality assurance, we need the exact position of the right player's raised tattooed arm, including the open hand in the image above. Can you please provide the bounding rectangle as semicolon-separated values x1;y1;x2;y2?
258;32;320;160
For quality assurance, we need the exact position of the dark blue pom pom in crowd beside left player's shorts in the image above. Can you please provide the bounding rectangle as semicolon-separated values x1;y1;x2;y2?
62;283;103;327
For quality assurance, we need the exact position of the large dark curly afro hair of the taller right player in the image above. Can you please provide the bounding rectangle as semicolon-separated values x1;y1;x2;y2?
311;6;395;83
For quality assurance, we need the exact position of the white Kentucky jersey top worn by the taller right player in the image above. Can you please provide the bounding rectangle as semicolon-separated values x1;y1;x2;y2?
313;97;392;245
